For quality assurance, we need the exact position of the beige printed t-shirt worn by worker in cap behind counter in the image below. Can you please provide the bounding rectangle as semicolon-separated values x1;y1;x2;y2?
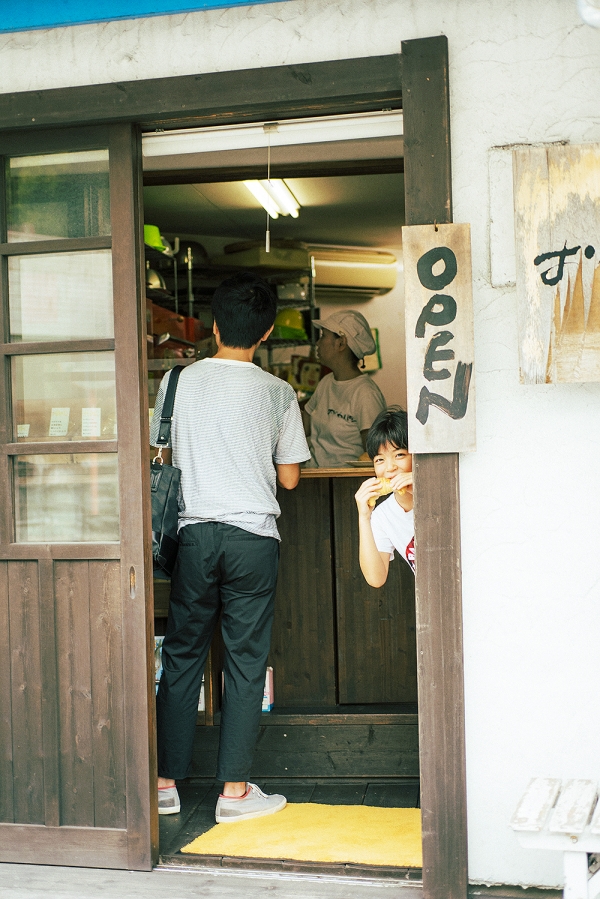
305;374;386;468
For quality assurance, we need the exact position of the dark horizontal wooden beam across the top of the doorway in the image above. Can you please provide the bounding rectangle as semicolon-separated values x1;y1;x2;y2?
0;54;402;131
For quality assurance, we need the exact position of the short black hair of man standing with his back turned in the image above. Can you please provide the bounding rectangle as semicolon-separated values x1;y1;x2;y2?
211;272;277;350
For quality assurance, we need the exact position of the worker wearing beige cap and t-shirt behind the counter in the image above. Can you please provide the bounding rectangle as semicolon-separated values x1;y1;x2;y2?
304;309;386;468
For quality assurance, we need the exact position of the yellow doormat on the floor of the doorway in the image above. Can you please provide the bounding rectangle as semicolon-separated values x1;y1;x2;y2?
181;802;422;868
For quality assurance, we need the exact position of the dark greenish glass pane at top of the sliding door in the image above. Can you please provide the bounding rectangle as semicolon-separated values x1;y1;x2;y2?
6;150;110;242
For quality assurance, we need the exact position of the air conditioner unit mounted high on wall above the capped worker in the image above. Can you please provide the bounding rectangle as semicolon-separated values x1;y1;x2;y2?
310;247;397;304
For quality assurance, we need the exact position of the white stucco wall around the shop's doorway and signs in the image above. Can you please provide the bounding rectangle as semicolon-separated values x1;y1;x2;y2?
0;0;600;886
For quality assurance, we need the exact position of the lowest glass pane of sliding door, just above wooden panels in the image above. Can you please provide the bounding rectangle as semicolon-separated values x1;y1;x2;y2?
13;453;119;543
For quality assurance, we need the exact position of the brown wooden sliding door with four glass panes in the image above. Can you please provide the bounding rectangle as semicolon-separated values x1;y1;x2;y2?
0;125;157;869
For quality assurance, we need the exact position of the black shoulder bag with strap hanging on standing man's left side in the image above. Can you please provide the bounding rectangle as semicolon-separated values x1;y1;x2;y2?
150;365;183;578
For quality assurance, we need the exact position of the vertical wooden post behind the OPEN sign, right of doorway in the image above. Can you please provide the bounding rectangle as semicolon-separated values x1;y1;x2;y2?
402;36;468;899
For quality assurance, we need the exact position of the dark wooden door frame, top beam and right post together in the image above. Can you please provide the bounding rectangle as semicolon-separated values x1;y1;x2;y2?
0;36;467;899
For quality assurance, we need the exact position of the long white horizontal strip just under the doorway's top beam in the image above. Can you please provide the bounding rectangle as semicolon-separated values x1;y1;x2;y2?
142;110;403;157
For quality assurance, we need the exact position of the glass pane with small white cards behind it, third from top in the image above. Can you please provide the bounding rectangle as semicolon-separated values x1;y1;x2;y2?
11;352;117;443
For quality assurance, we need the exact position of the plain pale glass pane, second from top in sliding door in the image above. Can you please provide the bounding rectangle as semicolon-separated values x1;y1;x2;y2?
8;250;114;342
